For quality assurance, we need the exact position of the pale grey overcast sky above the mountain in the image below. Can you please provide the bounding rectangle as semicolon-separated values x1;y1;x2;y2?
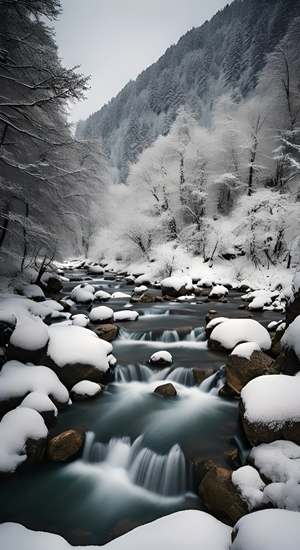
56;0;230;121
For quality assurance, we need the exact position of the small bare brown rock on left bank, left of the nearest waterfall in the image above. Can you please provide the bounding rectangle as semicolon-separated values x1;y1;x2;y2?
47;430;85;462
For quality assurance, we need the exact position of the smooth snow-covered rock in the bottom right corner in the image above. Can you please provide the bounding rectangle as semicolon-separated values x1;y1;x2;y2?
230;510;300;550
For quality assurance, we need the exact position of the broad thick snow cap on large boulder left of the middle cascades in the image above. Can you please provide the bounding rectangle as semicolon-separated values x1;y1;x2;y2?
47;325;112;372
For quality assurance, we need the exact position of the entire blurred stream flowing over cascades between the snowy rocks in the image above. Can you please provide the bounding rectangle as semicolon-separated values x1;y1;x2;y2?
0;272;277;545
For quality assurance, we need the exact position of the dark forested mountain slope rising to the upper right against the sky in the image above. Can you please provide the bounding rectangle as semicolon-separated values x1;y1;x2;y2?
77;0;300;185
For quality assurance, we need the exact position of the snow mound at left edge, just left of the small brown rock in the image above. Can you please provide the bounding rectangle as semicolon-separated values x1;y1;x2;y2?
0;407;48;474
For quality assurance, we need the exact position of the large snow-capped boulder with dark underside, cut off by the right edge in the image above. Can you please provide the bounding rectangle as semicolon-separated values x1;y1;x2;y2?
241;374;300;445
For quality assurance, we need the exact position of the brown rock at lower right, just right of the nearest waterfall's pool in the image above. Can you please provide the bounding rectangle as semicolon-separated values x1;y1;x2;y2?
199;465;249;525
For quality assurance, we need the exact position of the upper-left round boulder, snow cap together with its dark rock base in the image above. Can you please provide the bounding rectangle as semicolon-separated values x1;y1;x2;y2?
7;317;49;363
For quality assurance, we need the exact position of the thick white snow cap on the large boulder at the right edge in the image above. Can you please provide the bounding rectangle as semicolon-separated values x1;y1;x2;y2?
241;374;300;427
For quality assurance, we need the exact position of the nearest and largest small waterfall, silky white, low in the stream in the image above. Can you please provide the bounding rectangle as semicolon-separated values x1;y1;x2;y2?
83;434;191;496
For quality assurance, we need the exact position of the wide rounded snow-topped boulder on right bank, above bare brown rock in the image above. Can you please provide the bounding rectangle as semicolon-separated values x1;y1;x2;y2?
208;319;272;351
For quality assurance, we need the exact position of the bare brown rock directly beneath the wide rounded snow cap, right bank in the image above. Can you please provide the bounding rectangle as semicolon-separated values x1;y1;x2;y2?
225;351;274;395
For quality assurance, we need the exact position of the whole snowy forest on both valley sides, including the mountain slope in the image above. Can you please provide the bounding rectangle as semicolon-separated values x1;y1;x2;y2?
0;0;300;280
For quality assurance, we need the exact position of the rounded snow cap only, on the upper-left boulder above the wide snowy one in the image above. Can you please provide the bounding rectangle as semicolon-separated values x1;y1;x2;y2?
9;317;49;351
